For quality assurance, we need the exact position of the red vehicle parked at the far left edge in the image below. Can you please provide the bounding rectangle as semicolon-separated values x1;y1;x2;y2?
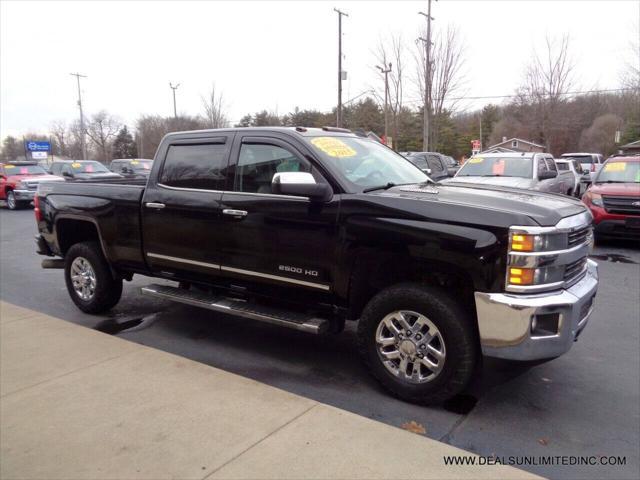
0;162;64;210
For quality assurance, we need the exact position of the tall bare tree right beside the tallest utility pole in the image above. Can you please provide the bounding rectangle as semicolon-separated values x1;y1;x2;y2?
415;25;465;150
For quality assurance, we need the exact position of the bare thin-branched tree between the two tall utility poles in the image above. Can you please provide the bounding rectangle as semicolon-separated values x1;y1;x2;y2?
374;34;405;146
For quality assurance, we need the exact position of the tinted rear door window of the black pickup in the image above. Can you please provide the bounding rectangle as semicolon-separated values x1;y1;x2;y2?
160;143;227;190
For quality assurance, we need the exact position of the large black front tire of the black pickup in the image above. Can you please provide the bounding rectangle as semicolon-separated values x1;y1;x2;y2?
358;284;480;405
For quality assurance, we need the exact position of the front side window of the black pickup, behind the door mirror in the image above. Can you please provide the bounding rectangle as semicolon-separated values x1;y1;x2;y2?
233;144;311;193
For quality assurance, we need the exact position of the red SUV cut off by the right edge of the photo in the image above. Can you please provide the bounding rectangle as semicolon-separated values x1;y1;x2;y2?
582;155;640;238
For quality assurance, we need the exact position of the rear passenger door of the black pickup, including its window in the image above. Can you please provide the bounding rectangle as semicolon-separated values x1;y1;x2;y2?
142;133;233;281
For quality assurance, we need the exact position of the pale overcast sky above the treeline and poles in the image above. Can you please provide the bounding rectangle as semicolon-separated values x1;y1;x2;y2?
0;0;640;137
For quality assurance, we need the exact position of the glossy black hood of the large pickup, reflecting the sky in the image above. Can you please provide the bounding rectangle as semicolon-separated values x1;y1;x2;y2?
380;181;587;226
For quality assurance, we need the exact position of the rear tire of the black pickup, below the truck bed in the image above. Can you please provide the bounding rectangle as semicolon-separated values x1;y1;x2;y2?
64;242;122;313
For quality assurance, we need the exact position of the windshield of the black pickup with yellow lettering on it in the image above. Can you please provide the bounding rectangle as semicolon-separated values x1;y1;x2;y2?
309;137;429;189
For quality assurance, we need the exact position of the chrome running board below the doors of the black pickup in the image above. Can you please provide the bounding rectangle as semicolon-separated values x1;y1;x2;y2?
140;284;329;334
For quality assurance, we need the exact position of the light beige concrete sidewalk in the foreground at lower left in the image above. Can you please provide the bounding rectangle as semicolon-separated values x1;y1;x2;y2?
0;302;538;479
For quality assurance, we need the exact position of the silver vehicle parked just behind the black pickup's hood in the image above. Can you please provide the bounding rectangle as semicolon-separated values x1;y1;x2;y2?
444;152;574;195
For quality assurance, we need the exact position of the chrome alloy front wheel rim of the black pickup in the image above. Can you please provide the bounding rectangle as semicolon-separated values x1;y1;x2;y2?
376;310;447;383
